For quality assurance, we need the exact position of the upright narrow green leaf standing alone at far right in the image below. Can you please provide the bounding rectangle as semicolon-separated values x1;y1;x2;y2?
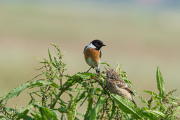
156;66;165;100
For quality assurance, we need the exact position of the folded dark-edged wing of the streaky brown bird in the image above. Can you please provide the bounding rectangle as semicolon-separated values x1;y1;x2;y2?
115;79;134;95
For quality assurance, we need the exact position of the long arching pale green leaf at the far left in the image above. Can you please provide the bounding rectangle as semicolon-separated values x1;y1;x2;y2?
3;80;51;100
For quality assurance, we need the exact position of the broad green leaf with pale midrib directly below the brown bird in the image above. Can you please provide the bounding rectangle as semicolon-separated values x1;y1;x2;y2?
111;94;143;119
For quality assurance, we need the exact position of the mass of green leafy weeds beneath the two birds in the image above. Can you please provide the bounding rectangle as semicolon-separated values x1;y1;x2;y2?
0;44;180;120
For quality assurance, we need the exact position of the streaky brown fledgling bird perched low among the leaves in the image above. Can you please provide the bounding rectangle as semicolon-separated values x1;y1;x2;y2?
105;67;137;105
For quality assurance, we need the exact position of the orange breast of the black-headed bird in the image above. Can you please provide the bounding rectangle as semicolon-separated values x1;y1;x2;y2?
84;48;100;62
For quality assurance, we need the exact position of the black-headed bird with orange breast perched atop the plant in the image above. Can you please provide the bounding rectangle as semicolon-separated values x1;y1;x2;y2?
83;39;106;74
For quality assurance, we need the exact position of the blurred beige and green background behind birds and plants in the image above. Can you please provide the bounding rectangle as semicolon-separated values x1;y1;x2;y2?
0;0;180;118
